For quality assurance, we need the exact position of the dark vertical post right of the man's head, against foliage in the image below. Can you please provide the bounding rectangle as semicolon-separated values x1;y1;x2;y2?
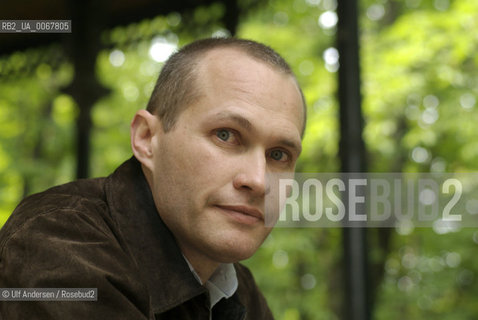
337;0;370;320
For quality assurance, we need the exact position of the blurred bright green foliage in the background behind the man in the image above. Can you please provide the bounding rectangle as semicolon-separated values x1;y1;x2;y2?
0;0;478;320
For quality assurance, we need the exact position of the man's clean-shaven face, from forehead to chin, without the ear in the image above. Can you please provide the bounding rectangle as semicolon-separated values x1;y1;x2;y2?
150;49;304;263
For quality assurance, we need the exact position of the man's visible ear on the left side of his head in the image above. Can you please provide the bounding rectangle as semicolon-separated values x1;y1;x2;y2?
130;110;162;171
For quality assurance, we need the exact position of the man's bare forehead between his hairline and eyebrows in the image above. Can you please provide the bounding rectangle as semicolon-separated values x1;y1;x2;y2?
196;48;305;132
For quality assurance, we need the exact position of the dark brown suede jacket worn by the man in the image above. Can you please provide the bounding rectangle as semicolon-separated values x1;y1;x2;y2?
0;157;273;320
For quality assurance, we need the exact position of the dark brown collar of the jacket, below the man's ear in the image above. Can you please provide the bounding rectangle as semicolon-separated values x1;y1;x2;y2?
105;157;206;313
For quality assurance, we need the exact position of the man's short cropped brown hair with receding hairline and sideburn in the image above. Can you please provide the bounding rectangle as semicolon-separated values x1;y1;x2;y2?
146;38;307;135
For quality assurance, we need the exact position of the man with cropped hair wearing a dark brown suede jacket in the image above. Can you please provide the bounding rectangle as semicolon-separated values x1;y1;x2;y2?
0;39;305;320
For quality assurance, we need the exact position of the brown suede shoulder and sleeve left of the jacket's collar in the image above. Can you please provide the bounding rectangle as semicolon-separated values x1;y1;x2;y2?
0;178;149;319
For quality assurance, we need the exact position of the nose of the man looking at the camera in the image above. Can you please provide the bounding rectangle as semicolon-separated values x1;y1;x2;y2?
233;150;268;196
